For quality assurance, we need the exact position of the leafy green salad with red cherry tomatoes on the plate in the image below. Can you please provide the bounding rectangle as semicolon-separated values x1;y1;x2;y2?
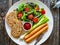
17;2;46;23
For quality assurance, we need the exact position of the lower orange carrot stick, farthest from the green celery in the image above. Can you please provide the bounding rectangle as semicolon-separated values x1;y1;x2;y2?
25;25;48;43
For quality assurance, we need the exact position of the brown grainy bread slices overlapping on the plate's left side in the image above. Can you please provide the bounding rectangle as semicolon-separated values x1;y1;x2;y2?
6;11;22;38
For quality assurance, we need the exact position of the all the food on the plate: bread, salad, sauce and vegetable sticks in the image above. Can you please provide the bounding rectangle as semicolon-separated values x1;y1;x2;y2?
6;2;49;43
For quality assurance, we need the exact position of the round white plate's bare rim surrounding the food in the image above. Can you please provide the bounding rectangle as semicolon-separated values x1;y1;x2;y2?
5;0;53;45
